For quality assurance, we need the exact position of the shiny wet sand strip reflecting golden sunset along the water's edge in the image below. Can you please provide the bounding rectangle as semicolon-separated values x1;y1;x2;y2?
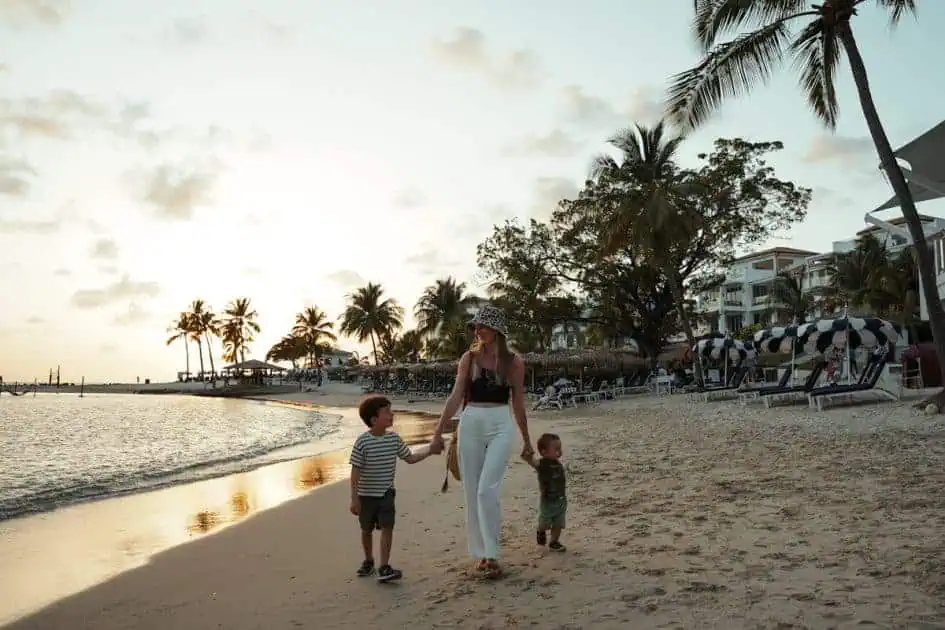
0;398;442;626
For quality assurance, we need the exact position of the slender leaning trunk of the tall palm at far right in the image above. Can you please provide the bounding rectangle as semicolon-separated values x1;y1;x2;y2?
837;22;945;409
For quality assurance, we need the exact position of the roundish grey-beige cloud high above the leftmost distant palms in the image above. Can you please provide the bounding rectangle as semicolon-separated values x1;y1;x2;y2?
142;164;219;221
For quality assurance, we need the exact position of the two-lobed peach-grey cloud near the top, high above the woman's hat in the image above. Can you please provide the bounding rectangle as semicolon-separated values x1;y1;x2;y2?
433;26;542;89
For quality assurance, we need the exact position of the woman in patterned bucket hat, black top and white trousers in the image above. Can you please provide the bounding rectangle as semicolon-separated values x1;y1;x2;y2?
433;305;535;578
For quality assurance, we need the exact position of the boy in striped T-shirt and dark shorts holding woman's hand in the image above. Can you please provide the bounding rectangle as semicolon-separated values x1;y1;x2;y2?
350;396;441;582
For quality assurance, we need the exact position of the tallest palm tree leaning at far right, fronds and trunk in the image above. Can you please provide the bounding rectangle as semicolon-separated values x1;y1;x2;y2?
668;0;945;396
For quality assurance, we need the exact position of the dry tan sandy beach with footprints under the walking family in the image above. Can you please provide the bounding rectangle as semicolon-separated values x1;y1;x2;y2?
1;392;945;630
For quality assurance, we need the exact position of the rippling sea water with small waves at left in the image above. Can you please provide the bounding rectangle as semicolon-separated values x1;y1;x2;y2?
0;394;351;520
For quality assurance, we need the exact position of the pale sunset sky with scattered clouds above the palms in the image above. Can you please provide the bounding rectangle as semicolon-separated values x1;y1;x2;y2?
0;0;945;382
